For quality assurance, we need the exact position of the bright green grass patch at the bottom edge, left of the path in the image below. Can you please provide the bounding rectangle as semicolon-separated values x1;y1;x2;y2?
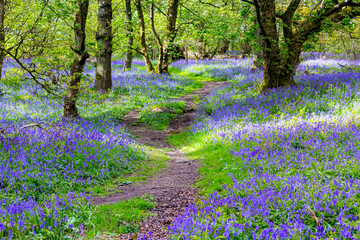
87;196;155;239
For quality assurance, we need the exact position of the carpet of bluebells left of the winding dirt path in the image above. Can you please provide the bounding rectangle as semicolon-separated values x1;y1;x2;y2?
0;60;194;239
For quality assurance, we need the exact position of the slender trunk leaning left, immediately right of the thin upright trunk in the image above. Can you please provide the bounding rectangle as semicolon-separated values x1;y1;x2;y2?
135;0;154;73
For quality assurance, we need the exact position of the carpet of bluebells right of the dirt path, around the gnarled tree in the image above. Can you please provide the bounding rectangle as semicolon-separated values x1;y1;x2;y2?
169;53;360;239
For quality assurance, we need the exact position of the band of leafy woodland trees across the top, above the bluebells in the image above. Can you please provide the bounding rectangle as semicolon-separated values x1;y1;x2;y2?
0;1;360;107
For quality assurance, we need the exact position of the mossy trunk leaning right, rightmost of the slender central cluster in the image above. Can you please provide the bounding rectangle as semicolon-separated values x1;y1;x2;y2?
161;0;180;73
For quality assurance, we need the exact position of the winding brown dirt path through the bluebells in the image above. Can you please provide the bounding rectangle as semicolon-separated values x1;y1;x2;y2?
93;82;226;240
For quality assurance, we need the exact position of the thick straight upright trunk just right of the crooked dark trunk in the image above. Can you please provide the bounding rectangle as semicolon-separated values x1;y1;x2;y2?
95;0;112;91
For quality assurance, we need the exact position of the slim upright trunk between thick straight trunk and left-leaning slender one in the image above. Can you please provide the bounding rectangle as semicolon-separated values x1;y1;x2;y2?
124;0;134;71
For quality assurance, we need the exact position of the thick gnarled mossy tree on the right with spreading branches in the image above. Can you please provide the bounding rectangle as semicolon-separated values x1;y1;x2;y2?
253;0;360;92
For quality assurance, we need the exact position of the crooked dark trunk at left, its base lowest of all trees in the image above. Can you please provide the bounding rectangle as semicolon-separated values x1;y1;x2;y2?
64;0;89;117
